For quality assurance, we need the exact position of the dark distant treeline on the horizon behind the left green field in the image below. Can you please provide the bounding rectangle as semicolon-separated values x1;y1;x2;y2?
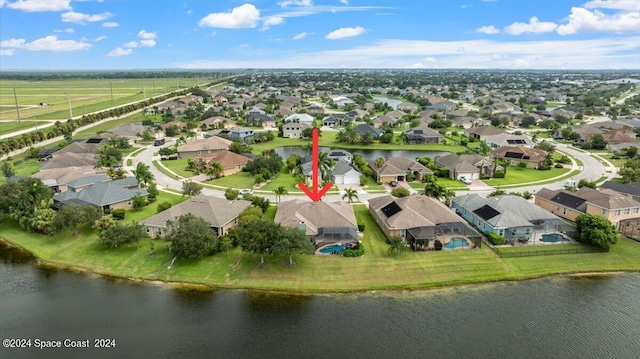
0;70;237;81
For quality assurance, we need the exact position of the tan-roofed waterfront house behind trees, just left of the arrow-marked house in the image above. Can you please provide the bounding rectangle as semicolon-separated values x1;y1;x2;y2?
143;194;251;238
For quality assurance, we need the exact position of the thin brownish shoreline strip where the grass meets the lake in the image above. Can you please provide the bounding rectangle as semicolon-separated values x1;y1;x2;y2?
0;237;640;295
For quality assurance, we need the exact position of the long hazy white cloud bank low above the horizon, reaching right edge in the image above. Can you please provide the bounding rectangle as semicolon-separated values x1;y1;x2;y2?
178;36;640;69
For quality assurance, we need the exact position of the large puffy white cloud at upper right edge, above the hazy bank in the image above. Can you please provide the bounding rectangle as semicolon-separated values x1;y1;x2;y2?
557;7;640;35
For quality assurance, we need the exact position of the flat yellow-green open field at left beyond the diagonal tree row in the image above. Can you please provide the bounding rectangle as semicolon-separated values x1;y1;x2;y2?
0;77;212;120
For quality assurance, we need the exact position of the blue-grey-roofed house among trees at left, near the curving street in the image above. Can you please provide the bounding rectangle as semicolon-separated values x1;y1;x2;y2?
53;175;149;212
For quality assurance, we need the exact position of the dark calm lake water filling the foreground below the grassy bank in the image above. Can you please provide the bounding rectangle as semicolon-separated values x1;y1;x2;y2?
0;242;640;359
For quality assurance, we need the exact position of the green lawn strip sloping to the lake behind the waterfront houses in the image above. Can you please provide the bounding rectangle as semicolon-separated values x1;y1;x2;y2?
0;205;640;292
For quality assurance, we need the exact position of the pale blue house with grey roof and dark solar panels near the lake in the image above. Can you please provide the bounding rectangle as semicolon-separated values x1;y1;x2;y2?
451;193;572;242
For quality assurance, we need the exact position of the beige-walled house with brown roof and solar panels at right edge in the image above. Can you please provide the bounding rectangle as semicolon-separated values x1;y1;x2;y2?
535;187;640;238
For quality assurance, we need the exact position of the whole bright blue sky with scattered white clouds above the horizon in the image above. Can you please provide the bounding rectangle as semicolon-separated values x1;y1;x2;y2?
0;0;640;70
